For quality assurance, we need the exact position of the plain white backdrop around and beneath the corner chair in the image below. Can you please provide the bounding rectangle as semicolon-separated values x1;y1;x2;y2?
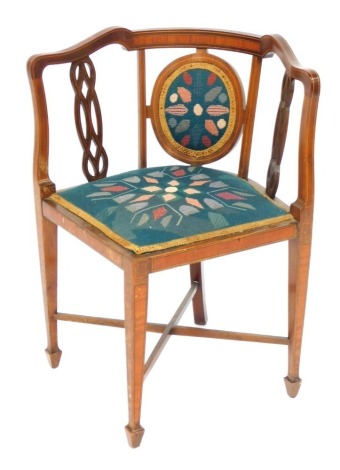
0;0;340;470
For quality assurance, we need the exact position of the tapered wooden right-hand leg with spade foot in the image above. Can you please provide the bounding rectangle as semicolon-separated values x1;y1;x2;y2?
285;239;311;398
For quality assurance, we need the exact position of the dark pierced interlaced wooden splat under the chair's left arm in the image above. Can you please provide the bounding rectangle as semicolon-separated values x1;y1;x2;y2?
70;57;108;181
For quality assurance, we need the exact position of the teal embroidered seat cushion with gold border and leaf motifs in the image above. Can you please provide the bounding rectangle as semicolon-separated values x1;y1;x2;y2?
51;165;291;254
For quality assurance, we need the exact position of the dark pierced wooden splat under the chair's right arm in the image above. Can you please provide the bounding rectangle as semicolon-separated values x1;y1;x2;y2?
266;74;294;198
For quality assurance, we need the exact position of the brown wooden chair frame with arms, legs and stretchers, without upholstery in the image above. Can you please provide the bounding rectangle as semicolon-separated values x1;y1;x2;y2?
28;28;320;447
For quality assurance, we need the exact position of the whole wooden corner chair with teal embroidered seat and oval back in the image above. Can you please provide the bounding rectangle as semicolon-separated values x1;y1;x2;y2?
28;28;320;447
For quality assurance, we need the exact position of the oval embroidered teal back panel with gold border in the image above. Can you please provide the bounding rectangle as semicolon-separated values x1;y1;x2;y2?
151;50;244;165
